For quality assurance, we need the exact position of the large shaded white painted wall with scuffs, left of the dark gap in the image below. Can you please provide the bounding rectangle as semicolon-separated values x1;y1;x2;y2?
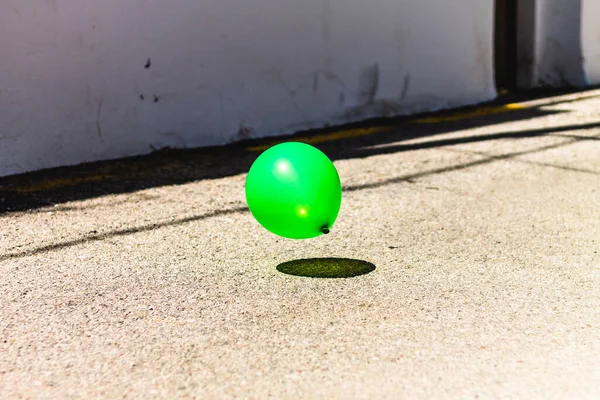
0;0;495;176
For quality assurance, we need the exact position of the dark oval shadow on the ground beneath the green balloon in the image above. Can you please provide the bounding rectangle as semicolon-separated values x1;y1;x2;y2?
277;258;375;278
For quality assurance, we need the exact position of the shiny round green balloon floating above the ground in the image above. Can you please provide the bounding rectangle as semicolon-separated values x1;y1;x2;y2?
246;142;342;239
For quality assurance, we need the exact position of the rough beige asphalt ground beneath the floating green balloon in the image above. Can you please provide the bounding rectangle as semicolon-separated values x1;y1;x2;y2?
0;92;600;399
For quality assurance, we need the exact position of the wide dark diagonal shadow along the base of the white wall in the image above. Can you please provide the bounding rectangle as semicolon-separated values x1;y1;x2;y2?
0;88;593;215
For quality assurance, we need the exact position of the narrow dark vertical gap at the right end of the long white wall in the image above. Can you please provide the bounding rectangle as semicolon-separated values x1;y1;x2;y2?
494;0;518;92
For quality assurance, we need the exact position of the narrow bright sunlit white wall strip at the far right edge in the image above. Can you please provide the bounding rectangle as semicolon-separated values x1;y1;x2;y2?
581;0;600;85
